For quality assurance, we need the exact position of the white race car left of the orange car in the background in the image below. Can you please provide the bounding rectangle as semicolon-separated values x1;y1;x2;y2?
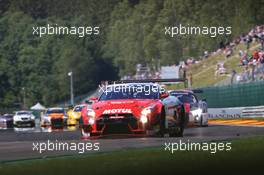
13;111;36;127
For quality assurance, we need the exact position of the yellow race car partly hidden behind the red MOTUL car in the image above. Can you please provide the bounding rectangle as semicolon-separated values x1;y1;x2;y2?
67;104;86;125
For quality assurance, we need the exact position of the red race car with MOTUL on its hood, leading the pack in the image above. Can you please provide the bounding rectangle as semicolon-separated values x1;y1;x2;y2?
81;83;188;138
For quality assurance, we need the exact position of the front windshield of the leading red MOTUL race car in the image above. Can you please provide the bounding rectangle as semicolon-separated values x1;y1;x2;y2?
99;85;159;101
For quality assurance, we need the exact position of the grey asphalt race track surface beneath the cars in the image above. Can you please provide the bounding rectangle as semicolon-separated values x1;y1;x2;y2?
0;125;264;161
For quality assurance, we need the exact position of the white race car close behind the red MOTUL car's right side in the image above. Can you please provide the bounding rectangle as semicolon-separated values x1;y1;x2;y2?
169;90;208;126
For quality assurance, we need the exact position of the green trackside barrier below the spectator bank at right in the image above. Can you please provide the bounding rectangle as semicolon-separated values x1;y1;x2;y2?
197;81;264;108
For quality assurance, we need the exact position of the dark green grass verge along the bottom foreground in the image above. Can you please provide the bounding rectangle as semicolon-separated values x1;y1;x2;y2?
0;137;264;175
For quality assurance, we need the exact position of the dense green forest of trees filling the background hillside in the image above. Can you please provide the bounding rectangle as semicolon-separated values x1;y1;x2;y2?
0;0;264;108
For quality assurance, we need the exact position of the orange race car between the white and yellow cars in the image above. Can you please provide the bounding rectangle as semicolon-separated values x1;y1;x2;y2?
41;107;68;127
